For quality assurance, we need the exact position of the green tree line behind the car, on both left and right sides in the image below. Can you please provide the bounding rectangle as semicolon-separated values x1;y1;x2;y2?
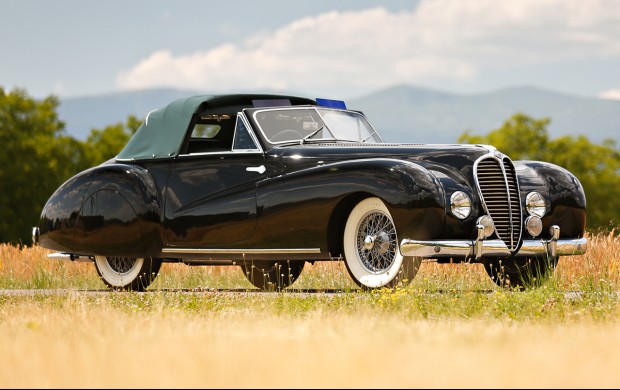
0;87;620;245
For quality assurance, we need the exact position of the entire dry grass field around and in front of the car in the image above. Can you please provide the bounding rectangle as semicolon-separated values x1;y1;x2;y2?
0;232;620;388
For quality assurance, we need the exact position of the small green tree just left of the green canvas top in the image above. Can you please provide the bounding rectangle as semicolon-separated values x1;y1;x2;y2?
85;115;142;165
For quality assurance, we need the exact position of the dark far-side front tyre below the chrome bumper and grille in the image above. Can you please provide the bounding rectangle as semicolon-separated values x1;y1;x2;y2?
484;257;558;290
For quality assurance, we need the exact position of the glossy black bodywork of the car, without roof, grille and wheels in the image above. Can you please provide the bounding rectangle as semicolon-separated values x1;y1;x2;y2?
39;93;586;261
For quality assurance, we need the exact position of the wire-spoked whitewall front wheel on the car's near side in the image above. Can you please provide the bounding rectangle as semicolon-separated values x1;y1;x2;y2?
343;198;422;289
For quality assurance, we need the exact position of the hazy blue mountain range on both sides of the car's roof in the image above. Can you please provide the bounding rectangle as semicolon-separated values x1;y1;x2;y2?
58;85;620;143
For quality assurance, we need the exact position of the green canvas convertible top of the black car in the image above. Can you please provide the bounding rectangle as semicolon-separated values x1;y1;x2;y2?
116;94;317;161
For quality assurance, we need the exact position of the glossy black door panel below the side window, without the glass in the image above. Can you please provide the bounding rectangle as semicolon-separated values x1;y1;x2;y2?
164;153;264;247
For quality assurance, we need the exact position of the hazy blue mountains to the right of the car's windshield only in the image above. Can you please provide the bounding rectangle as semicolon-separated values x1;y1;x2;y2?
347;86;620;143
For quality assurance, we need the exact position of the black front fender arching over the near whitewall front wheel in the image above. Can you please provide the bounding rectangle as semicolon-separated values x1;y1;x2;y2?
256;158;445;248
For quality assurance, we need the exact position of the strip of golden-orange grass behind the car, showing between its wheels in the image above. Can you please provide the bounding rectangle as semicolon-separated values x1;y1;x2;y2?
0;231;620;290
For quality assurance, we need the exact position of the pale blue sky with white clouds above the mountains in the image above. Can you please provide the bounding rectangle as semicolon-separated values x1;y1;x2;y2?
0;0;620;99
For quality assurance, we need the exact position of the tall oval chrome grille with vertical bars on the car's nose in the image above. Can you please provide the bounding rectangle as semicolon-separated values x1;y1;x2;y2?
476;156;521;252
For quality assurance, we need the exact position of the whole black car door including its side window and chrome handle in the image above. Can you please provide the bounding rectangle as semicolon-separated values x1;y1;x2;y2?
164;115;265;248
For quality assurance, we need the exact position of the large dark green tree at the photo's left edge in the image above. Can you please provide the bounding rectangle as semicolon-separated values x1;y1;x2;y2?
0;87;88;243
